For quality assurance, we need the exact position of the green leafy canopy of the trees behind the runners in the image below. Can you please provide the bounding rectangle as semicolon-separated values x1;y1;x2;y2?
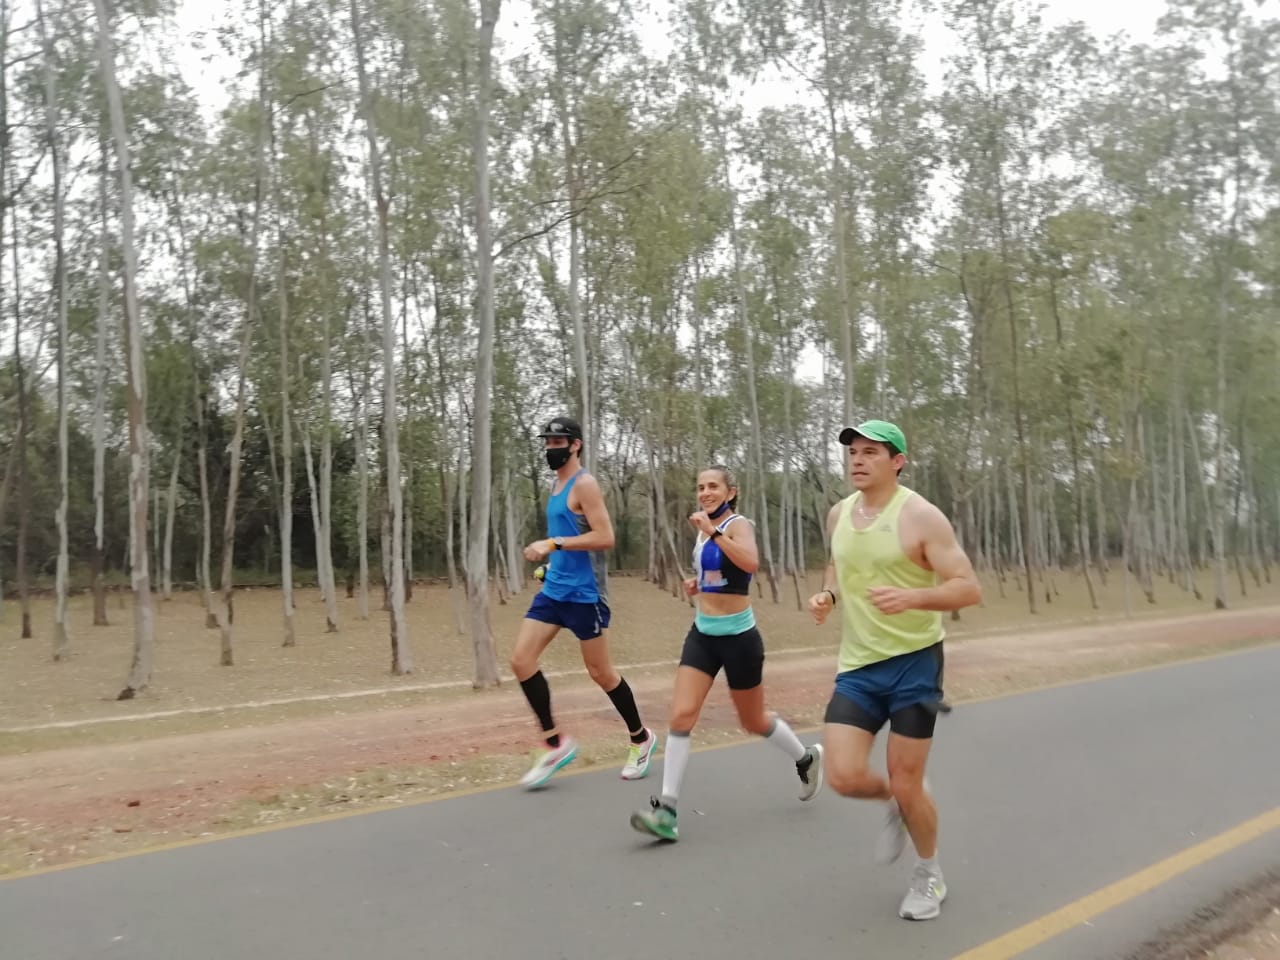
0;0;1280;601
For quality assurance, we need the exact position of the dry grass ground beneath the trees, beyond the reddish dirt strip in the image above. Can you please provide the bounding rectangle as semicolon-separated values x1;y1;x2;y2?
0;563;1280;737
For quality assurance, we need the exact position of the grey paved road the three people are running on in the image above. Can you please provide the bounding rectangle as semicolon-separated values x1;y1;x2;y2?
0;646;1280;960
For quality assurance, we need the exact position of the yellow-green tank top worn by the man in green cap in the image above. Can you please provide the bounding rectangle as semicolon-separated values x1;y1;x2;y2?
831;486;945;673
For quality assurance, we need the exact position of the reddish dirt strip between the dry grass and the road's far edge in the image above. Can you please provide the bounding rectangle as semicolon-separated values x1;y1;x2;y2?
0;599;1280;873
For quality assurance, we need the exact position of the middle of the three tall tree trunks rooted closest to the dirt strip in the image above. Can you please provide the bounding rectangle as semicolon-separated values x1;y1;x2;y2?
351;0;413;676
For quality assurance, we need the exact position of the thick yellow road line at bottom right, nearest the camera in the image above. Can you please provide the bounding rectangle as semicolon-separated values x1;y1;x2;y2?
951;806;1280;960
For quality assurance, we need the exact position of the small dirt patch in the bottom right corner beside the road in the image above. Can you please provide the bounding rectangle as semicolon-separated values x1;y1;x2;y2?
1125;870;1280;960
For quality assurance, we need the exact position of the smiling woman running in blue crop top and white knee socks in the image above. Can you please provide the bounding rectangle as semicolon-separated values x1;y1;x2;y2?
631;463;822;841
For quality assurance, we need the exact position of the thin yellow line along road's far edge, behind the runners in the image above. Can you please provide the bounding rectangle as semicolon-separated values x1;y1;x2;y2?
0;641;1280;883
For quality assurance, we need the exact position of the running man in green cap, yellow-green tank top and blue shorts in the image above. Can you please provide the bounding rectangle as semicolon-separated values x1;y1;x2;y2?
809;420;982;920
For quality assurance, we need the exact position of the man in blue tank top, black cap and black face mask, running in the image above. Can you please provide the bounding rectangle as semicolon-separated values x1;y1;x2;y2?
511;417;658;788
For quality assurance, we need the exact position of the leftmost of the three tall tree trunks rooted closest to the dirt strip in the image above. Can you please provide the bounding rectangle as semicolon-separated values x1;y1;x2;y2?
93;0;154;700
